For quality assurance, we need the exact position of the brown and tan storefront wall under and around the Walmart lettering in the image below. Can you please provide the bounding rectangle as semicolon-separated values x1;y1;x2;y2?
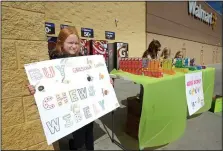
146;1;222;64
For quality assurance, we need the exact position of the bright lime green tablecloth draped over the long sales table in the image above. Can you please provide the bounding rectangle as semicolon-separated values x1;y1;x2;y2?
112;68;215;149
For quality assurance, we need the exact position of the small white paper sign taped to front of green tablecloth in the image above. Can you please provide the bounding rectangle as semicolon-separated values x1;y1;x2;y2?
185;72;204;115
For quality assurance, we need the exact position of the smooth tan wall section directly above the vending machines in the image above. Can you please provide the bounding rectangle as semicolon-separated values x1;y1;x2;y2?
45;2;146;56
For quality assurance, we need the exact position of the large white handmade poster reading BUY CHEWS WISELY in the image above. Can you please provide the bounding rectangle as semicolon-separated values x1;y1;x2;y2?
25;55;119;145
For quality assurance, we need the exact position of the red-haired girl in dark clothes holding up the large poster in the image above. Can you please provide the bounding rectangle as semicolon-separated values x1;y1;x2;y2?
28;27;94;150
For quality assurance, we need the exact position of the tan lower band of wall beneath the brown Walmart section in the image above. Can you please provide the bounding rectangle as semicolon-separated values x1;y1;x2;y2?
147;33;222;65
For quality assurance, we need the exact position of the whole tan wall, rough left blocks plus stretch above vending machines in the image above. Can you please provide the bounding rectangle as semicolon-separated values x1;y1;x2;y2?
2;2;146;150
